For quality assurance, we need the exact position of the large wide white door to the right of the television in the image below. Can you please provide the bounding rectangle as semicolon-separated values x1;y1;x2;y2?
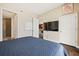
59;14;77;46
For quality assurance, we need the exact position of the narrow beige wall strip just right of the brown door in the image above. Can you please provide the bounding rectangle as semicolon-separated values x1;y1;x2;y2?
11;14;18;38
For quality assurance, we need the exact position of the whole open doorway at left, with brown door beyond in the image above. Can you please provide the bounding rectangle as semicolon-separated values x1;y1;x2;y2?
2;10;16;41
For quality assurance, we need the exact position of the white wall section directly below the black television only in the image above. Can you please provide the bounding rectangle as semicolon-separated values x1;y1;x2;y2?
43;31;59;42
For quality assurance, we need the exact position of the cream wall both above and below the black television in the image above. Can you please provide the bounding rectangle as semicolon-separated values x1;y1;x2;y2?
39;6;63;41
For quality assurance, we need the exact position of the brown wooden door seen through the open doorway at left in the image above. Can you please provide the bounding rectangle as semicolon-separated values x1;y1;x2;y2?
3;18;11;40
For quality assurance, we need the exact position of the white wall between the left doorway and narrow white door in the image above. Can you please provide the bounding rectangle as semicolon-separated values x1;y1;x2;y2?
0;4;32;37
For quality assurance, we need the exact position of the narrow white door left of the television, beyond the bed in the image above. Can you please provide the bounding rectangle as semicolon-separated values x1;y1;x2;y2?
32;18;39;37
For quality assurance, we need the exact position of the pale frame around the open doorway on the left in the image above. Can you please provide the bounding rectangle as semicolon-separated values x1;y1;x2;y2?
1;9;18;41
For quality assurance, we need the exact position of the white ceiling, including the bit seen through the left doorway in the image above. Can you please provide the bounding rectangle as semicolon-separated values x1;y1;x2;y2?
1;3;63;16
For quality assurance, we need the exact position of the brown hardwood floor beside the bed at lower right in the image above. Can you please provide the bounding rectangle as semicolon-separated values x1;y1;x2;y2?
62;44;79;56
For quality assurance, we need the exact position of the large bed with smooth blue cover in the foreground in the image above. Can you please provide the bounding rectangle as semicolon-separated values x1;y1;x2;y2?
0;36;68;56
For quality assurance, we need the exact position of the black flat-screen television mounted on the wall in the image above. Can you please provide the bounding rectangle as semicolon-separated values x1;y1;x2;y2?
44;21;59;31
